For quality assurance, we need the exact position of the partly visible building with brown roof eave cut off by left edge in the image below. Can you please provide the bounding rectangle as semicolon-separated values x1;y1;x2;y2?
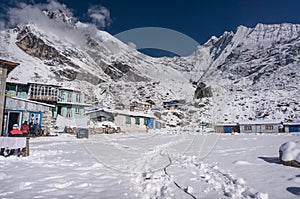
0;59;19;134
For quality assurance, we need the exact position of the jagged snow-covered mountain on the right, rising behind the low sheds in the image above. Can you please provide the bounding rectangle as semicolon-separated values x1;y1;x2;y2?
190;24;300;121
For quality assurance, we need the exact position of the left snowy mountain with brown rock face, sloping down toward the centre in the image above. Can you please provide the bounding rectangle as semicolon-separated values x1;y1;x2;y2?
0;10;194;106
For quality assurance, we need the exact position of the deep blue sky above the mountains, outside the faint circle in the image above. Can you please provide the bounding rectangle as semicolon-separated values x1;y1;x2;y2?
0;0;300;56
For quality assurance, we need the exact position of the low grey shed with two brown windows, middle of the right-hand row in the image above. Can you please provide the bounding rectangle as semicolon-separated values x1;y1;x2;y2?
239;121;282;133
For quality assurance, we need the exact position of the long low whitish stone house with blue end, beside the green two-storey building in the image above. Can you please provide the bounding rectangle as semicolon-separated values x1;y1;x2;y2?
86;109;163;132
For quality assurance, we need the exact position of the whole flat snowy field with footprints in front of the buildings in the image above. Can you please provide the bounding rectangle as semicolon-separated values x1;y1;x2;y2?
0;129;300;199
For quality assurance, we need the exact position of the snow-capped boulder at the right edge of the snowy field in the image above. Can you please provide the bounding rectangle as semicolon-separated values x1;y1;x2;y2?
279;141;300;168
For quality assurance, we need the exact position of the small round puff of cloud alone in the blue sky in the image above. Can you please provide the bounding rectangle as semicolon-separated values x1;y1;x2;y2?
88;5;112;28
